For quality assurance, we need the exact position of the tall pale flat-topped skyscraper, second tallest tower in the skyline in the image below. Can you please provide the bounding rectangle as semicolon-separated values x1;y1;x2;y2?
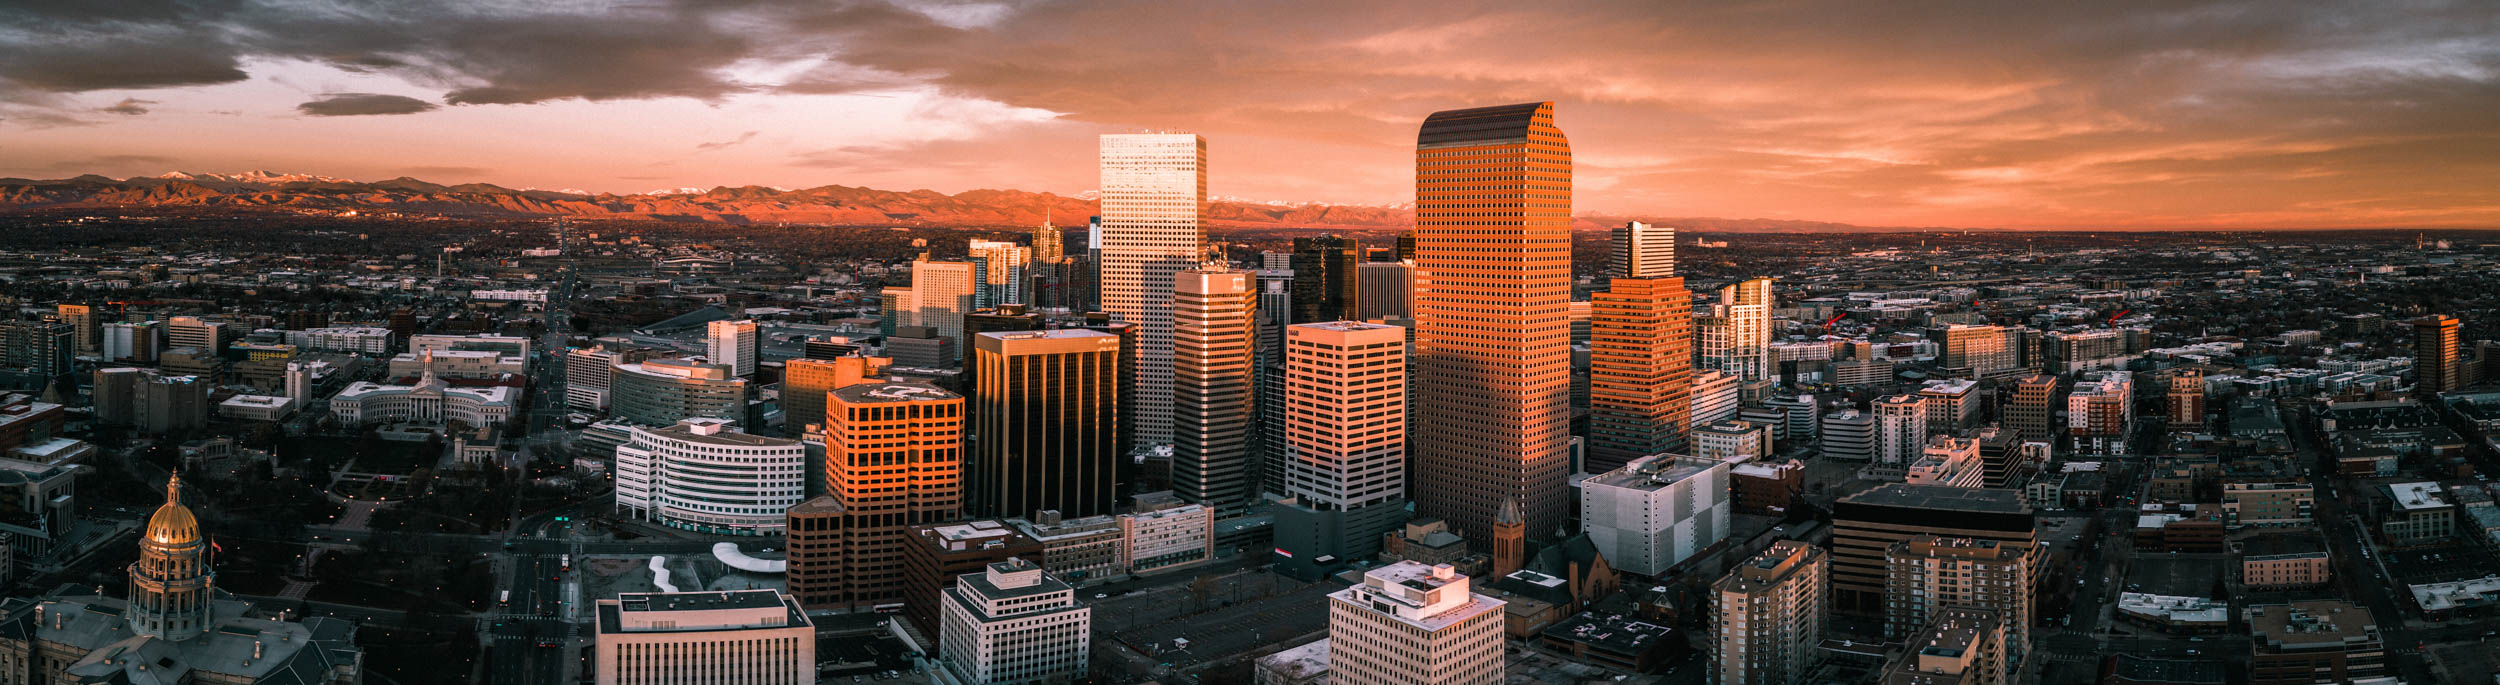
1100;133;1208;450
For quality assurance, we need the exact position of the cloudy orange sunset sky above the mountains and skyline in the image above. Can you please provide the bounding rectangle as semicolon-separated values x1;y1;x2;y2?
0;0;2500;228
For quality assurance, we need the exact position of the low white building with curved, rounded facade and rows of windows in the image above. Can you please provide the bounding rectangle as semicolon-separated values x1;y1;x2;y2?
615;418;808;535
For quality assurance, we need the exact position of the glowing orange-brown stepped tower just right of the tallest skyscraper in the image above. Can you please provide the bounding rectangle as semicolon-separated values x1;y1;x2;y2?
1585;278;1693;473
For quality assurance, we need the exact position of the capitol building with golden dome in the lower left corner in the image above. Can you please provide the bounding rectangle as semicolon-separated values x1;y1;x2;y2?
0;475;365;685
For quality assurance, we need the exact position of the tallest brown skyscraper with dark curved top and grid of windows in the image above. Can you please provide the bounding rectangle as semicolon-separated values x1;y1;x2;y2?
1413;103;1570;545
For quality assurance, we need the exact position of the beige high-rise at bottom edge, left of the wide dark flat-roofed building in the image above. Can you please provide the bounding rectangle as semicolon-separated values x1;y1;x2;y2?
1710;540;1833;685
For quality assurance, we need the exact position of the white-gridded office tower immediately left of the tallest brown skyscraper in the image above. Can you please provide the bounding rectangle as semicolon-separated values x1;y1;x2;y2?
1275;323;1408;578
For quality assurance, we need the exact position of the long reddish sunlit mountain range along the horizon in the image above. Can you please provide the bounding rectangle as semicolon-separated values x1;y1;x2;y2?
0;173;2050;233
